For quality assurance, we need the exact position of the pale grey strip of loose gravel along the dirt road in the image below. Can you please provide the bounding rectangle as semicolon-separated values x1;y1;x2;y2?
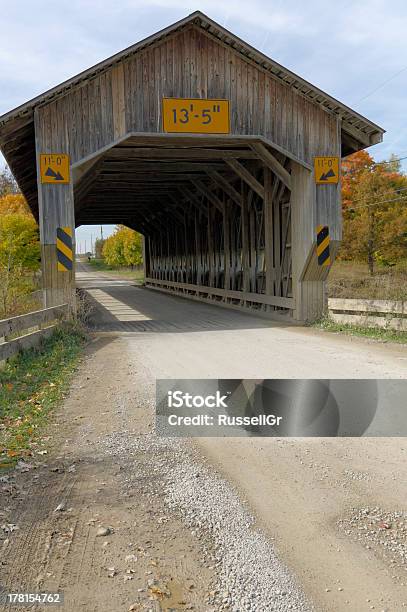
106;412;314;612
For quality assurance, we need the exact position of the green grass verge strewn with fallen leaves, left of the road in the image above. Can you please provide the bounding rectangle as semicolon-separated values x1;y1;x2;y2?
0;325;86;467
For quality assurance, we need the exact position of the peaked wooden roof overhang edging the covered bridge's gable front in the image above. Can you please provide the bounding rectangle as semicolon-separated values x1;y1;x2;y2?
0;11;384;216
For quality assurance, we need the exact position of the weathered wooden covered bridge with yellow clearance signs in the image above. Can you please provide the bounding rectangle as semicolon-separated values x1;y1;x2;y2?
0;12;383;321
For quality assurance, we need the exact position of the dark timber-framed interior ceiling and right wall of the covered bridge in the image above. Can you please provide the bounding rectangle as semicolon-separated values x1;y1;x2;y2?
74;135;294;316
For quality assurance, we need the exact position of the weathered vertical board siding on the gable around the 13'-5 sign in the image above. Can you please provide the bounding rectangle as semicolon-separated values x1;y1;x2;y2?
37;27;340;164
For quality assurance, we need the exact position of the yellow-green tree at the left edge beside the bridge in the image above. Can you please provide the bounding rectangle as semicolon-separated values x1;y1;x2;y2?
0;213;40;314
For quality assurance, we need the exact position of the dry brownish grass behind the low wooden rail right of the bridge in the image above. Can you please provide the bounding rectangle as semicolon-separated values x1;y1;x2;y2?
328;260;407;300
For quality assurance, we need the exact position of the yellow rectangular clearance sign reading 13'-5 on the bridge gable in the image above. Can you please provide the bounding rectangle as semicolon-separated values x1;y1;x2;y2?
162;98;230;134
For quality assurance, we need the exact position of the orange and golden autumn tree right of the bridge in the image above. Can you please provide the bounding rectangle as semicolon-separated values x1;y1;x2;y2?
339;151;407;274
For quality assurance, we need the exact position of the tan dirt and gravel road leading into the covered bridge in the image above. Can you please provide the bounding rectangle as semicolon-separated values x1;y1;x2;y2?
0;271;407;612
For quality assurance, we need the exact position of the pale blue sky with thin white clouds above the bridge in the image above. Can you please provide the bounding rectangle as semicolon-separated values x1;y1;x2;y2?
0;0;407;250
